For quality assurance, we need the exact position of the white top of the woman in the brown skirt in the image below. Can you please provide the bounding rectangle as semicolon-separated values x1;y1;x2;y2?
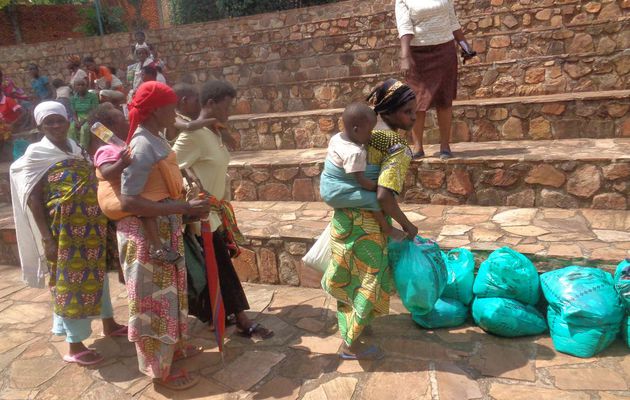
396;0;461;46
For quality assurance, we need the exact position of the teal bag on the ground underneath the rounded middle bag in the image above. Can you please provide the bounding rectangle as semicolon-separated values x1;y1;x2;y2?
472;297;547;337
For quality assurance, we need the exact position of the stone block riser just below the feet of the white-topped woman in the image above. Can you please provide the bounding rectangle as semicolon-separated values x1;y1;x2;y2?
230;158;630;210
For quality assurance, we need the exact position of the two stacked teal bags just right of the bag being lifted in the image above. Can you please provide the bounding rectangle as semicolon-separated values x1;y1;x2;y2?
411;249;475;329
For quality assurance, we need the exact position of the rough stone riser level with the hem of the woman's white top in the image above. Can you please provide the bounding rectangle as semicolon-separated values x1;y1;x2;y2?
160;16;630;78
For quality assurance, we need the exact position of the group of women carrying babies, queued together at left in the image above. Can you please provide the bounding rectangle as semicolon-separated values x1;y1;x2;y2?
11;77;273;389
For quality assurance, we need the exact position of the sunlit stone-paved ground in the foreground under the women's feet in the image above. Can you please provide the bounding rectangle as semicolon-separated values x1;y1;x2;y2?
0;266;630;400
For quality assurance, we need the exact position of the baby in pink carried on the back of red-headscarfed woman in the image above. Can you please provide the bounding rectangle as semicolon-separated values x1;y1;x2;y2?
91;103;182;263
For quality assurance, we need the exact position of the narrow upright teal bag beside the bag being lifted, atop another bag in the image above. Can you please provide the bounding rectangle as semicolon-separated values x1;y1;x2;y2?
442;249;475;305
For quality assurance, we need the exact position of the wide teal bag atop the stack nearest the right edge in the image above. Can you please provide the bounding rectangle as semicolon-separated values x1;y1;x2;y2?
540;266;625;327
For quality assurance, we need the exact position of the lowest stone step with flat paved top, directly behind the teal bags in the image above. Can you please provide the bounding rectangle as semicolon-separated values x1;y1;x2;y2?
234;202;630;287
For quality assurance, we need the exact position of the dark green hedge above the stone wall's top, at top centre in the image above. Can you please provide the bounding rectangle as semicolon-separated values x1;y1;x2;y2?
170;0;339;25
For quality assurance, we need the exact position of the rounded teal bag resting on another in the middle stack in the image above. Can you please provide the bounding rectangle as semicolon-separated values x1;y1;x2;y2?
473;247;540;305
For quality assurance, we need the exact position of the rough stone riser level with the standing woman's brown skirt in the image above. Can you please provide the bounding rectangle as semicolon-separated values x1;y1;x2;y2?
221;49;630;114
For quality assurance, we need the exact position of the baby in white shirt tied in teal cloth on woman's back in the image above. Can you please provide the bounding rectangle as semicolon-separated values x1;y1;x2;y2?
320;103;406;240
